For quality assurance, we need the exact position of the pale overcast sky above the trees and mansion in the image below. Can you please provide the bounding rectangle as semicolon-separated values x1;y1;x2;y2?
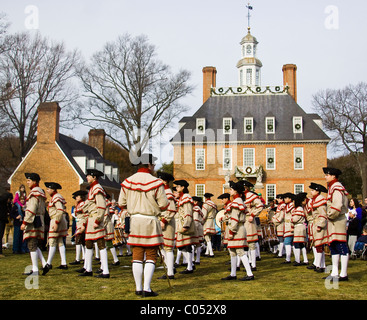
0;0;367;164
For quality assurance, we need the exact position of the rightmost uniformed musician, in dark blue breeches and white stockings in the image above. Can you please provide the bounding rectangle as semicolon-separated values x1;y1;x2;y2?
323;167;349;281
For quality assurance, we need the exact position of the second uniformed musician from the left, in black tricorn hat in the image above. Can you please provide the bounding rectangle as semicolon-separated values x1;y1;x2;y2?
42;182;68;275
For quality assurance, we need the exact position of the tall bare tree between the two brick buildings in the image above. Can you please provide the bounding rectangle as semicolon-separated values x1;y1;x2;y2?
76;34;193;159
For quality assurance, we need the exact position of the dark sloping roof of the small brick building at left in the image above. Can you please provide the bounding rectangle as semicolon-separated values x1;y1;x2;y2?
57;133;120;189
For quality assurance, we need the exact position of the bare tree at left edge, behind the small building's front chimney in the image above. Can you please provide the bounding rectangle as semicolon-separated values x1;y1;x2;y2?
0;33;79;157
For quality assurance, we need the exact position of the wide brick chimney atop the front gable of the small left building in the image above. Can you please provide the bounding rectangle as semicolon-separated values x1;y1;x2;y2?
37;102;61;143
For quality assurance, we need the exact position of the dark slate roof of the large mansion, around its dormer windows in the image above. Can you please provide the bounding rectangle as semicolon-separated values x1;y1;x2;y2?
171;94;330;143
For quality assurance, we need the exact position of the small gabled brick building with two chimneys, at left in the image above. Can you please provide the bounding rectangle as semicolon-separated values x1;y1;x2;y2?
8;102;120;213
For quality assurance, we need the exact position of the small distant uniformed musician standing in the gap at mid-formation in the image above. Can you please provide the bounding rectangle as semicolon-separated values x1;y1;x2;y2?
201;192;217;258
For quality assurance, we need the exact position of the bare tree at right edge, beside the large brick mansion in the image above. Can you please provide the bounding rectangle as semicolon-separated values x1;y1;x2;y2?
313;82;367;197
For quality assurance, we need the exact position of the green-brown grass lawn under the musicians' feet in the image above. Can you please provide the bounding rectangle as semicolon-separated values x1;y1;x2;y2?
0;245;367;301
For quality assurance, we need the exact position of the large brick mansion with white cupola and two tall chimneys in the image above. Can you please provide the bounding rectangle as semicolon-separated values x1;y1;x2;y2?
171;29;330;201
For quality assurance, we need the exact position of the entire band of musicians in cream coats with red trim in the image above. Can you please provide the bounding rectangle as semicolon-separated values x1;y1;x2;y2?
21;154;348;297
